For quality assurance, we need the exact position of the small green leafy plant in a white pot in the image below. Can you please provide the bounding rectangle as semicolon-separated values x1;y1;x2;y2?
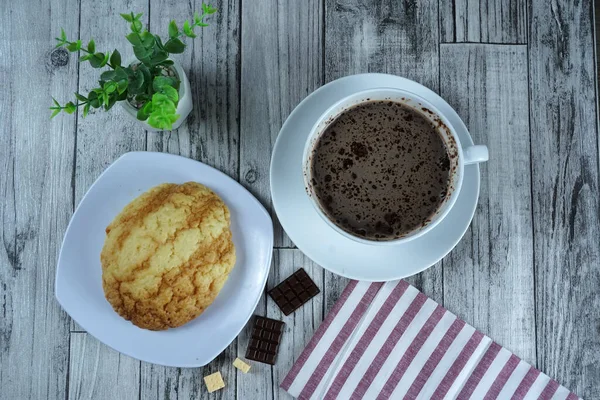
50;4;217;131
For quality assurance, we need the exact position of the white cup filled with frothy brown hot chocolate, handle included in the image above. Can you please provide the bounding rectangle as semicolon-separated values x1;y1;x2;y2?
302;88;488;245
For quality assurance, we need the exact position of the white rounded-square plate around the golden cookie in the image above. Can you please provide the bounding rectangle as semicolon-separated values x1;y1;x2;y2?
56;152;273;367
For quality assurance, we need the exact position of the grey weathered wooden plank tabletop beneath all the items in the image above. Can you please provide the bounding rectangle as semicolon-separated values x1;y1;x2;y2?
0;0;600;400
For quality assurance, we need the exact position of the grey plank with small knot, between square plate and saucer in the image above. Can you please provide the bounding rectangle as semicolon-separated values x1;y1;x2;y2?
240;0;323;247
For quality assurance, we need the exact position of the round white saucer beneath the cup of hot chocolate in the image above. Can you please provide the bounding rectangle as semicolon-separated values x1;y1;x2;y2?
271;74;479;281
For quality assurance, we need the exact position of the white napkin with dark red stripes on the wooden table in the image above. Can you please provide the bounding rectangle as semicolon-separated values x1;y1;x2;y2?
281;280;578;400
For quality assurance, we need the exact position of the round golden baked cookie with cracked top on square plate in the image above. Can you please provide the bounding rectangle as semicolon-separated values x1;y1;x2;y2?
100;182;235;330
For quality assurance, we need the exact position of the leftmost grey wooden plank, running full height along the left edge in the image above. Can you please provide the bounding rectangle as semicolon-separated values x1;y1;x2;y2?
0;1;78;399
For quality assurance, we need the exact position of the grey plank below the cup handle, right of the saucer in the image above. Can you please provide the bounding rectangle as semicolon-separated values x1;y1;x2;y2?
440;44;536;365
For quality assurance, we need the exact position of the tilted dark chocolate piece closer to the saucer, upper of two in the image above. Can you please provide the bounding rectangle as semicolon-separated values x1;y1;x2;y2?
269;268;320;315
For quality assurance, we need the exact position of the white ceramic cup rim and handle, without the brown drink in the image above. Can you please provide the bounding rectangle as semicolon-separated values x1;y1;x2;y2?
302;88;489;245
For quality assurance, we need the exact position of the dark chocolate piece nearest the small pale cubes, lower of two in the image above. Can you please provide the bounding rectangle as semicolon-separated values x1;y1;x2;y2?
246;316;285;365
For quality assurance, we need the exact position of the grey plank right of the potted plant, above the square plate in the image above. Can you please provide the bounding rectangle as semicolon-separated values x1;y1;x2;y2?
147;0;240;179
